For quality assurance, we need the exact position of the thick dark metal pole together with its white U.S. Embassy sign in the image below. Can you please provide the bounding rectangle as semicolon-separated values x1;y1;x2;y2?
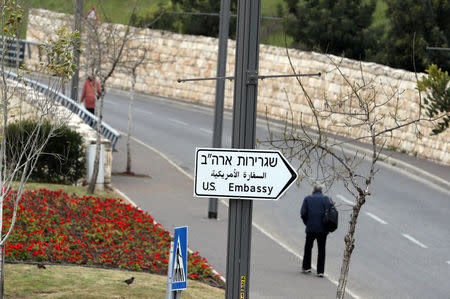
192;0;298;299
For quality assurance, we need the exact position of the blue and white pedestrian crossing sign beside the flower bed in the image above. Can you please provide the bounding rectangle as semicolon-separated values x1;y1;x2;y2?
171;226;187;291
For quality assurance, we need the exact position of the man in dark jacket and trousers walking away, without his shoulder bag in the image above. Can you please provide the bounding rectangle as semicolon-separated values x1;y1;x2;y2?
300;185;331;277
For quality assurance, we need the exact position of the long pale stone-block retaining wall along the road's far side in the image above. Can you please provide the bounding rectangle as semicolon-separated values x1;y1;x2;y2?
27;10;450;165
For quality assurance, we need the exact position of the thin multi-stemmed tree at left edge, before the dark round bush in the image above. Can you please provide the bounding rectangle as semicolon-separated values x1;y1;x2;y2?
0;0;79;297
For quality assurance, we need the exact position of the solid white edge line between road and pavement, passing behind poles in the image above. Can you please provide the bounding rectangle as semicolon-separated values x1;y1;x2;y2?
124;131;360;299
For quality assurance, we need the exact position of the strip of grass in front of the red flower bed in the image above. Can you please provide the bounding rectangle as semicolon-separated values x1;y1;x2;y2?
5;264;225;298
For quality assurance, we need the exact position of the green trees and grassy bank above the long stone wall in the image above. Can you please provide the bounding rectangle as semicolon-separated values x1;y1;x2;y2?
29;0;450;71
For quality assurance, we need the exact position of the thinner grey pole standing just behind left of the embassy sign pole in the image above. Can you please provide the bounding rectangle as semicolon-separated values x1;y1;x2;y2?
208;0;230;219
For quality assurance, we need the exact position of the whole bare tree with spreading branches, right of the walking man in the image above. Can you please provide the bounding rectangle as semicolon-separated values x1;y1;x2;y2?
261;53;440;298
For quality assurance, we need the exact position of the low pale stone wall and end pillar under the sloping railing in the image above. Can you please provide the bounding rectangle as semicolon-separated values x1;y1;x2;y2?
8;79;112;186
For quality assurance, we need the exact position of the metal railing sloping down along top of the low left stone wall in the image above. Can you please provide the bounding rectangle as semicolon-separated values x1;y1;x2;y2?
5;71;120;150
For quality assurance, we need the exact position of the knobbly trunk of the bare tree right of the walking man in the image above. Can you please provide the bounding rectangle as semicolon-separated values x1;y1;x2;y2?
336;195;366;299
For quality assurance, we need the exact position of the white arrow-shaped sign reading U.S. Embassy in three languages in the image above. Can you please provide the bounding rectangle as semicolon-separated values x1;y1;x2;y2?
194;148;297;200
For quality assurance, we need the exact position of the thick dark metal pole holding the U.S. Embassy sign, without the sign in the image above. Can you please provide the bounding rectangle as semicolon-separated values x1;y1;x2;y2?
225;0;261;299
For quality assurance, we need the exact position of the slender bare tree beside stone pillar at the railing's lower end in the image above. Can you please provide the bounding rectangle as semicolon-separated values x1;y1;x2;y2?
87;1;137;193
